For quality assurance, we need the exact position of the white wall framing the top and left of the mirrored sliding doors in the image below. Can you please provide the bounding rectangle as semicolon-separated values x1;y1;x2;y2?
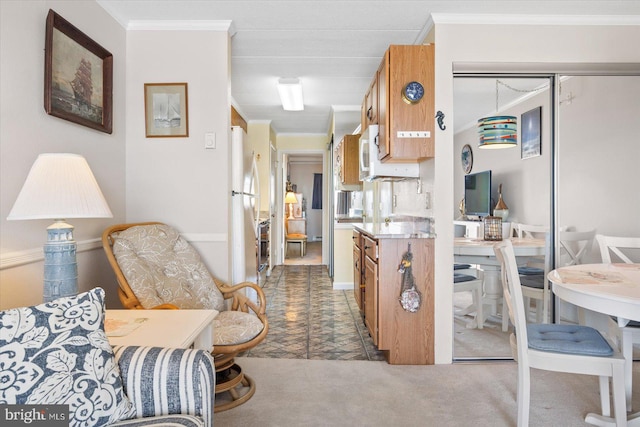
428;15;640;363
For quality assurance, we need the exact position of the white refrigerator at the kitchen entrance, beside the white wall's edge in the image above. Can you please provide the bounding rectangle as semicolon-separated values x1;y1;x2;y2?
231;126;260;290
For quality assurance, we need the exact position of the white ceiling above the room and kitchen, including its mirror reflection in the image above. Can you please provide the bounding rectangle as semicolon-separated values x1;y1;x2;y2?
97;0;640;134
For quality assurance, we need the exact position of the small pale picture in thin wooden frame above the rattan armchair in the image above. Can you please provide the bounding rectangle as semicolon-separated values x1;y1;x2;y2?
144;83;189;138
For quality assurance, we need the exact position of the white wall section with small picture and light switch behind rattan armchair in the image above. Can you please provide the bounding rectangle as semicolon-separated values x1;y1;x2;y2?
126;27;231;280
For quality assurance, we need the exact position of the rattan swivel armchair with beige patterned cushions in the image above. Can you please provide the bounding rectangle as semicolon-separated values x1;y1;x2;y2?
102;222;269;412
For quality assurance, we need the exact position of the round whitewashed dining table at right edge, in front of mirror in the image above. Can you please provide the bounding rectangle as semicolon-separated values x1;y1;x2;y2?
547;264;640;426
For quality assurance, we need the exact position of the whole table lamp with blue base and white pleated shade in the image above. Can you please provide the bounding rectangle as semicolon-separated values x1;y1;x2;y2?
7;153;113;302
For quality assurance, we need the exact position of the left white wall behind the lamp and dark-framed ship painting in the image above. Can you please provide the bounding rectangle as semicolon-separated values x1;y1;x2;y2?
0;0;128;309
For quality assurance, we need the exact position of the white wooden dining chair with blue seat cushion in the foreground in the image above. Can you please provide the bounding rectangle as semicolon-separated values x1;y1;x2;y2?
494;240;627;427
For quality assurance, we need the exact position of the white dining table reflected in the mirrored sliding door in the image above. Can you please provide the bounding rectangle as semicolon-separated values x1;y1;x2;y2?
453;237;546;331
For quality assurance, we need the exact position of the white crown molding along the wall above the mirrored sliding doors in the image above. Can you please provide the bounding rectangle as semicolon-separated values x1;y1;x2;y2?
431;13;640;26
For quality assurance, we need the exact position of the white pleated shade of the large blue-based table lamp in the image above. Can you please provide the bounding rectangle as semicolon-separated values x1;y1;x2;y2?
7;153;113;220
